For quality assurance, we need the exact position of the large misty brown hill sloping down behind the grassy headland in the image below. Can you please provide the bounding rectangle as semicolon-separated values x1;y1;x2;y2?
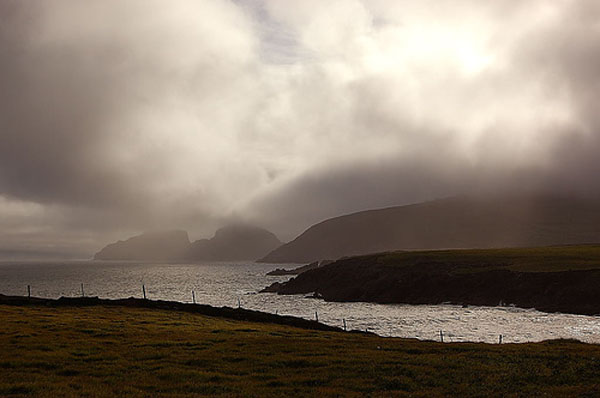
259;196;600;263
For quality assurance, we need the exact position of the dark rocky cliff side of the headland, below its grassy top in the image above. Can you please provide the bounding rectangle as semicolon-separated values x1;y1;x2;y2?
263;247;600;315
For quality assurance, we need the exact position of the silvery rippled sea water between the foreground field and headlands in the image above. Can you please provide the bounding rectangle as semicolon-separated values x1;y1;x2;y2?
0;261;600;343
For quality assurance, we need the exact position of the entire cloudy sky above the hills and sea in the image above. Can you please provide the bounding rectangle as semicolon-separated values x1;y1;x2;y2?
0;0;600;258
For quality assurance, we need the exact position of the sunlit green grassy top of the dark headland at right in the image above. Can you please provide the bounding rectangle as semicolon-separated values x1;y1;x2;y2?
378;245;600;272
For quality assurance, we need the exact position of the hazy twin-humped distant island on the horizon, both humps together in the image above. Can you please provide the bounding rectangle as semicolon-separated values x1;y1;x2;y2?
94;225;281;261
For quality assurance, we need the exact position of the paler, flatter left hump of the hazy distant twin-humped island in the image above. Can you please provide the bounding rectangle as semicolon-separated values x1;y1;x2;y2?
94;231;190;261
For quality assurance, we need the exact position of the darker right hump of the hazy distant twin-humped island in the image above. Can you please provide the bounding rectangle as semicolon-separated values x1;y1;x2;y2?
184;225;281;261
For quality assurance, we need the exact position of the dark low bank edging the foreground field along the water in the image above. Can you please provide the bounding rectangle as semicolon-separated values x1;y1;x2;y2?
0;294;341;331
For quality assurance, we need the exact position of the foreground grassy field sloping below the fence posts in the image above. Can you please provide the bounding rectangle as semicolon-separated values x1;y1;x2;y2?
0;305;600;397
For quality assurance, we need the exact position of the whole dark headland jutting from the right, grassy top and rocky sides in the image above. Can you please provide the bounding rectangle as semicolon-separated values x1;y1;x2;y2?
264;245;600;315
